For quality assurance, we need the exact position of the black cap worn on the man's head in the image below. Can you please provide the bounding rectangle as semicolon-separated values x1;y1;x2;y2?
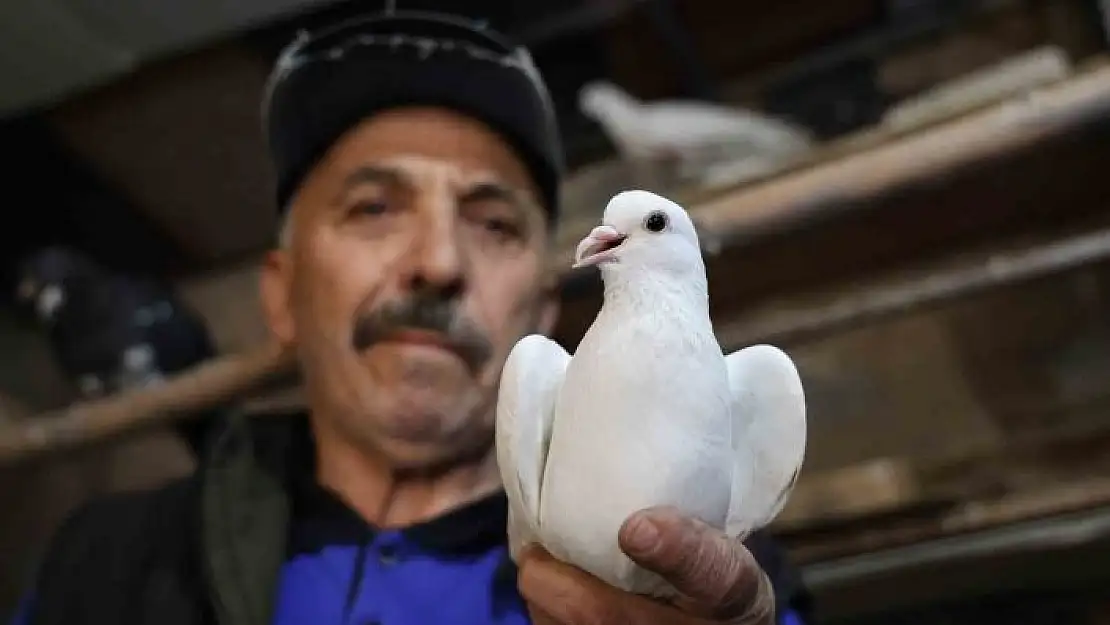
262;12;563;221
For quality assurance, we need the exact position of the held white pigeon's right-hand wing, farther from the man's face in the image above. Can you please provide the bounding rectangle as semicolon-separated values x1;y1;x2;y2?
725;345;806;536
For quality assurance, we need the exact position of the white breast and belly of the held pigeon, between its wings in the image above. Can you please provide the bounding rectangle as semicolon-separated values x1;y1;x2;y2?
541;322;731;582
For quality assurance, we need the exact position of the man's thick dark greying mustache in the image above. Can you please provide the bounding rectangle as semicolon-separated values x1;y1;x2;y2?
351;293;493;371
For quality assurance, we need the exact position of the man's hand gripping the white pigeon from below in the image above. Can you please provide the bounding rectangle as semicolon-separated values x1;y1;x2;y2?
519;507;775;625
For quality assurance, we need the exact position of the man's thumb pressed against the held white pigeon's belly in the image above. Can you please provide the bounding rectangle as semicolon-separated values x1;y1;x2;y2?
620;507;775;623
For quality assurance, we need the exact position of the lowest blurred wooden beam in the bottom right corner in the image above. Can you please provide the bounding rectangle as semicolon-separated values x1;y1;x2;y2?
803;501;1110;623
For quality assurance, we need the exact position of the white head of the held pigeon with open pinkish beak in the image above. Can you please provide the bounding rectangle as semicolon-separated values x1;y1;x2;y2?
574;191;704;274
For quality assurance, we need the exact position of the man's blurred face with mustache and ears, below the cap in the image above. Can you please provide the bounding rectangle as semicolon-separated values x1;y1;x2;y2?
263;108;554;468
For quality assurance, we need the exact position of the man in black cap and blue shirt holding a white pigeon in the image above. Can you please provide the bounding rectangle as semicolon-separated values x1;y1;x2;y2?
10;13;808;625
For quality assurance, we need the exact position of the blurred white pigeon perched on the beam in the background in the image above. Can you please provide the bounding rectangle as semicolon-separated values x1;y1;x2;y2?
578;81;814;184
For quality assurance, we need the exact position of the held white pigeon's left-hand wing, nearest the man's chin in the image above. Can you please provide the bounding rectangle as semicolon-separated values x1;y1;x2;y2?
496;334;571;561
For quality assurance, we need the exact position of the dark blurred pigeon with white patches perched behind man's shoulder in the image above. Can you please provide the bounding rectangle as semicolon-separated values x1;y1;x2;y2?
16;246;220;454
